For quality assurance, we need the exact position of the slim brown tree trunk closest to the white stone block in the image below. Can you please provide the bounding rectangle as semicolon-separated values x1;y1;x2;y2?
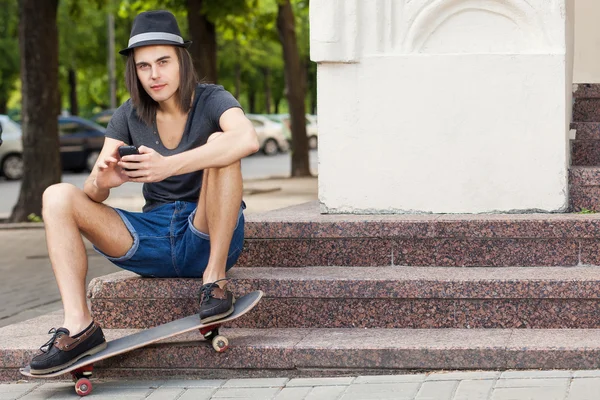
277;0;311;176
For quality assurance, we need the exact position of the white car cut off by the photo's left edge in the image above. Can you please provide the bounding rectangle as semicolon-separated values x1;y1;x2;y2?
0;115;23;180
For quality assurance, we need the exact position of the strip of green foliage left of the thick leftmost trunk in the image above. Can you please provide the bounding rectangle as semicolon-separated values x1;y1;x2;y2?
0;0;19;114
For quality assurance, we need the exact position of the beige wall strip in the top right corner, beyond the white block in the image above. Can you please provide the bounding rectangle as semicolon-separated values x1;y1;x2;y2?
573;0;600;83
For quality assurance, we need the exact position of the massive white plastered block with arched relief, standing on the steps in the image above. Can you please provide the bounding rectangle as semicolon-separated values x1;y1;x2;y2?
311;0;573;213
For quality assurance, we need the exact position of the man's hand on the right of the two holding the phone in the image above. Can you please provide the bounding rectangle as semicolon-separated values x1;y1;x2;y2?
118;146;173;183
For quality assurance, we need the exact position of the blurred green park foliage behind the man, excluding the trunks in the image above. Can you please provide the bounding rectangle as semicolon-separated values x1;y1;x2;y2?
0;0;316;119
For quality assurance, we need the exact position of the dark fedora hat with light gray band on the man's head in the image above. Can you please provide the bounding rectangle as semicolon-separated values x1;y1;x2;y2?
119;10;192;56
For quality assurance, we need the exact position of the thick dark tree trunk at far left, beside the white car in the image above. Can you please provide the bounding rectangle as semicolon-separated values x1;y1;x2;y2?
9;0;62;222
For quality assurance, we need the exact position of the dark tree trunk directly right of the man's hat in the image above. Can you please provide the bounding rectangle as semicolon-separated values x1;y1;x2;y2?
187;0;218;83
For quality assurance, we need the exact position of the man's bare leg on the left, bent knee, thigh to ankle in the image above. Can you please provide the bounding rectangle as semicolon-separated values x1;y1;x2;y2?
42;183;133;334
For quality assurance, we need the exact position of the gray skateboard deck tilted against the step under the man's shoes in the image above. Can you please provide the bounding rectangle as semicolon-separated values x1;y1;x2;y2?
19;290;264;378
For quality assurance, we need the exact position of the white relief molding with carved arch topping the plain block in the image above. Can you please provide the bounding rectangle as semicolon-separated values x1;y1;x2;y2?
311;0;567;62
